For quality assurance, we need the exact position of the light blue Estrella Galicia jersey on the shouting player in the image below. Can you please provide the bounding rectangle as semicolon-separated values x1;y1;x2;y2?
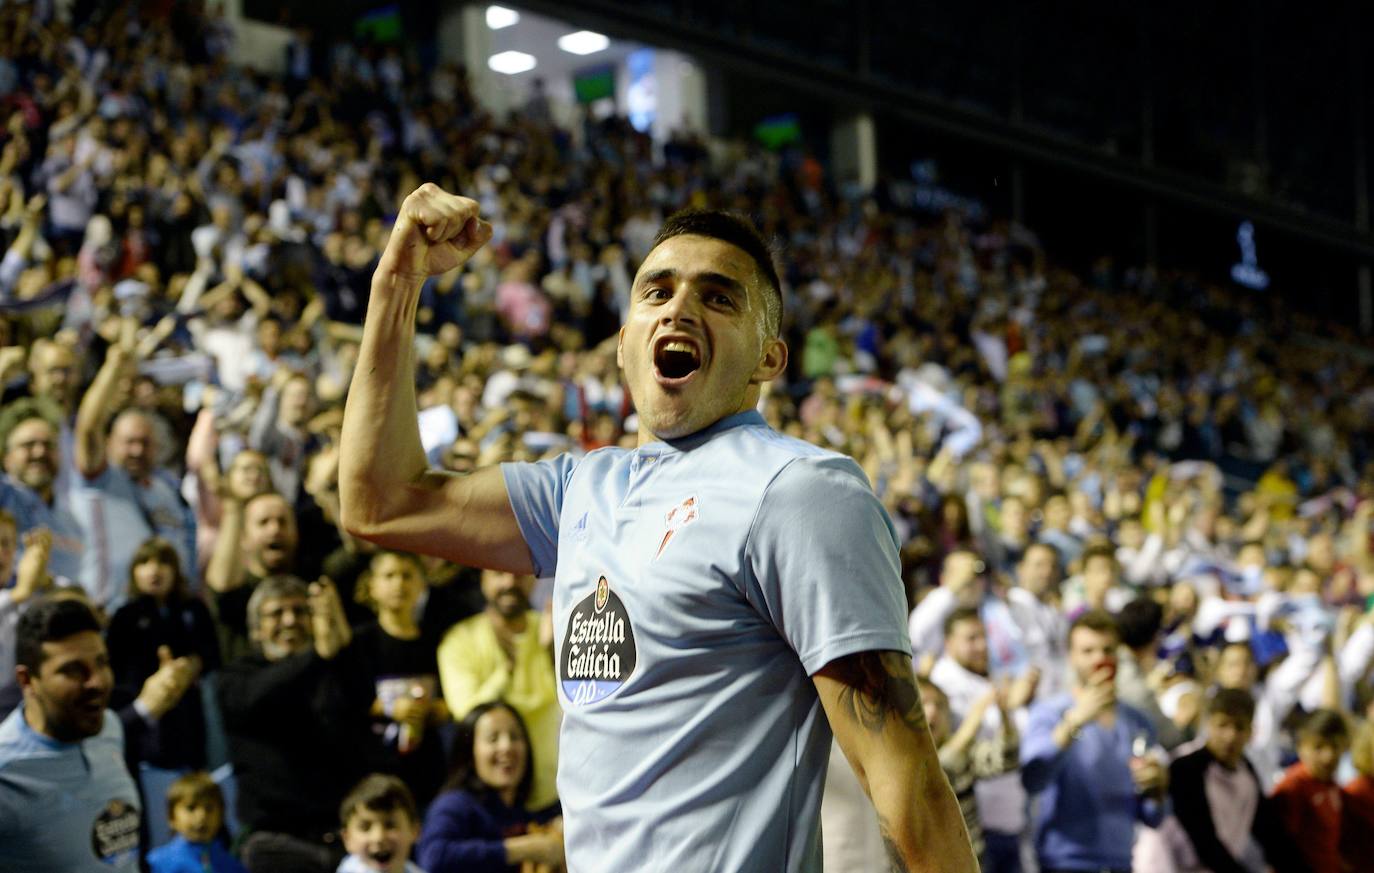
503;412;911;873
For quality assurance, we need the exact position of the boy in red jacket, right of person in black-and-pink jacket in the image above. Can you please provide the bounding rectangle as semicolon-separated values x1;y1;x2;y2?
1274;709;1351;873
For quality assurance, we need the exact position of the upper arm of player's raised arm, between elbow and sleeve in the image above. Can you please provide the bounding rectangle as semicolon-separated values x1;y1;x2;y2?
346;466;533;573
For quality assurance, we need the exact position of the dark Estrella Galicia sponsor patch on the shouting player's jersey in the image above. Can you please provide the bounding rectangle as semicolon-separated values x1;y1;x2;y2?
558;576;636;705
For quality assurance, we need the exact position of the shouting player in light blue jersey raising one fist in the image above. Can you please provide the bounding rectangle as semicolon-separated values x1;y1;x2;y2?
339;184;977;873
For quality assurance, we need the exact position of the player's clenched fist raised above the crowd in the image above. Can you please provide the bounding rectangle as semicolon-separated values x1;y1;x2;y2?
378;181;492;279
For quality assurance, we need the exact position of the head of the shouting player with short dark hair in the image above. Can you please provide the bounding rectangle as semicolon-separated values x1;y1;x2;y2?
616;235;786;439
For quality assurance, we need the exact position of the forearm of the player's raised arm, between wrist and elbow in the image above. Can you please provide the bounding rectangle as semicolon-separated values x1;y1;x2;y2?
339;271;429;533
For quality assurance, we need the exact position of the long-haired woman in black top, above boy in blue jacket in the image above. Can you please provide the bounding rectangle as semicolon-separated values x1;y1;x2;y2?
107;538;220;770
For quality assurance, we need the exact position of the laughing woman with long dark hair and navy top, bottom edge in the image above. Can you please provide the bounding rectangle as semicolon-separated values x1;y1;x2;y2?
416;700;563;873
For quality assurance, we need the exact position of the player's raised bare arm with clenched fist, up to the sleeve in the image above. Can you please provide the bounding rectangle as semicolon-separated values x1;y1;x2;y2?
339;186;533;573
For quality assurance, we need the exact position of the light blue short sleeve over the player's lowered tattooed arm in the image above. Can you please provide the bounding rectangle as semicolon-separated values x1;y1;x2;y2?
745;456;911;674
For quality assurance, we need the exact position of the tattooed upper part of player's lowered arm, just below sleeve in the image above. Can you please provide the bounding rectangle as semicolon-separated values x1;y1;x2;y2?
813;652;938;793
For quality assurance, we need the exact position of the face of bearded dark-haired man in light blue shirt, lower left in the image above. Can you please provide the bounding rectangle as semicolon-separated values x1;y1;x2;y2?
15;631;114;742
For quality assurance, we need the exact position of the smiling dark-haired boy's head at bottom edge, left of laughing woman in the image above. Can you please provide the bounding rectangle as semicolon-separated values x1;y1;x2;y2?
338;773;425;873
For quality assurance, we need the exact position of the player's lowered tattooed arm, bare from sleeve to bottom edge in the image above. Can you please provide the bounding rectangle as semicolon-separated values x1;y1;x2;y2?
813;652;978;873
